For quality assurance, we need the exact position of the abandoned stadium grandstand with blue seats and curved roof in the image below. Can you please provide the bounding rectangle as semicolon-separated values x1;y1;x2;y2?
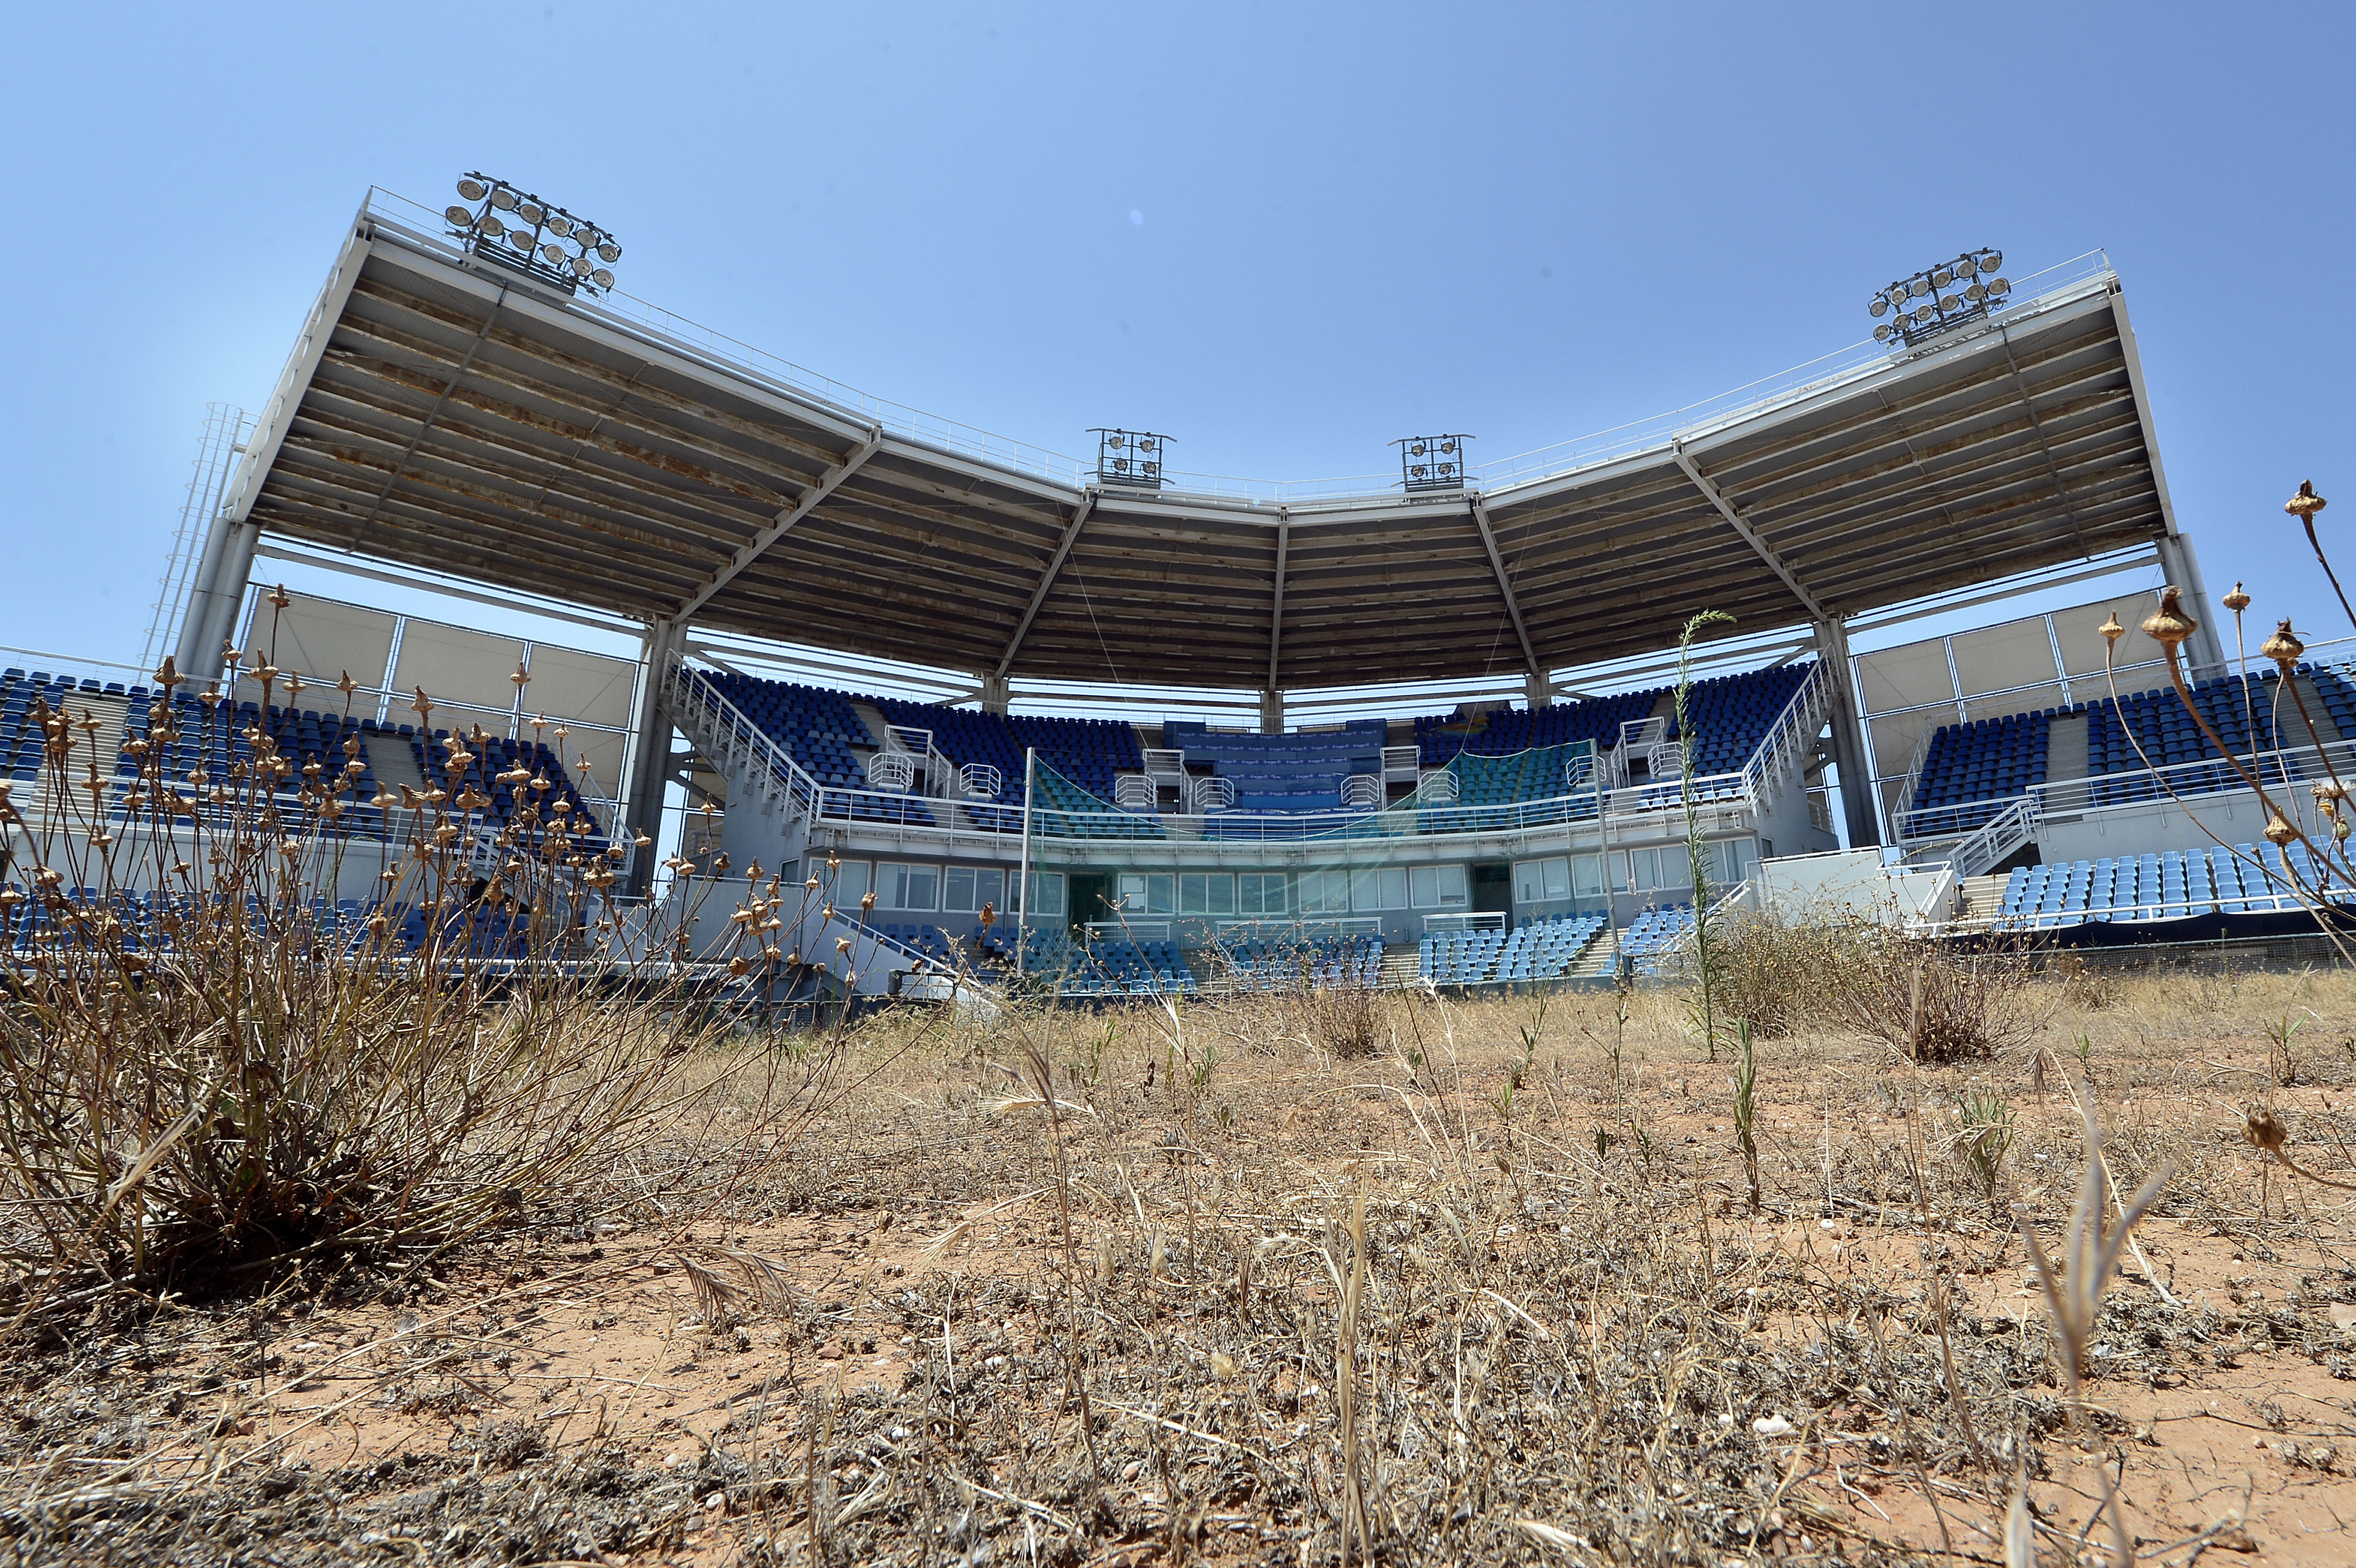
13;176;2356;1001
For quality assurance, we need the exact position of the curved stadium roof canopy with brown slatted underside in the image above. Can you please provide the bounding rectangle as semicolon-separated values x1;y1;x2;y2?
231;193;2175;690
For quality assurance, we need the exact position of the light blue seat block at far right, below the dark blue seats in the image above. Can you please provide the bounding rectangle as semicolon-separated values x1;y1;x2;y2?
1996;843;2356;930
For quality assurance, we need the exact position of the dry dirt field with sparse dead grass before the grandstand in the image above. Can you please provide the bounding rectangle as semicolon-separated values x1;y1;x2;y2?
13;965;2356;1568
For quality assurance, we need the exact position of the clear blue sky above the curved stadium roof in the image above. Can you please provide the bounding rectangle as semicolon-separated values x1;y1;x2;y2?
0;0;2356;659
